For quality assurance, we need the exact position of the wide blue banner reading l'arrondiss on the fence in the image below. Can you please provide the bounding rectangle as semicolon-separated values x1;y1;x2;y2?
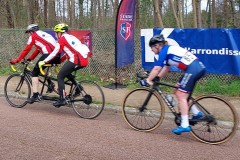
141;28;240;75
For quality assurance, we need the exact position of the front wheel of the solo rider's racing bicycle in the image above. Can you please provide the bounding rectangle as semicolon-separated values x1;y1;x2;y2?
122;88;165;131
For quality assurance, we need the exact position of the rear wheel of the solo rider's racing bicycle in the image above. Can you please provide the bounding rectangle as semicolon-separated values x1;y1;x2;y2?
190;96;238;144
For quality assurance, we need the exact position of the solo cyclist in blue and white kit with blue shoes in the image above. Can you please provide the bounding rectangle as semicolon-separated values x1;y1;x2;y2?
147;34;206;135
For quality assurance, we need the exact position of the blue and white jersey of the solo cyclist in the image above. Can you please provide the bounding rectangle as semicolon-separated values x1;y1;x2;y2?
154;45;197;70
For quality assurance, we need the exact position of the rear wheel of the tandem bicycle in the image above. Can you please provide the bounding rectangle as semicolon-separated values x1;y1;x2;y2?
71;80;105;119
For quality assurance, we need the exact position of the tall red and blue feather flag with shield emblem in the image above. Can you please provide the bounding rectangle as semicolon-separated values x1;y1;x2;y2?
115;0;136;68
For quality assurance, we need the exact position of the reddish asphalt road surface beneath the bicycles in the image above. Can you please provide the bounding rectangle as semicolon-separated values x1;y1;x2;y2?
0;97;240;160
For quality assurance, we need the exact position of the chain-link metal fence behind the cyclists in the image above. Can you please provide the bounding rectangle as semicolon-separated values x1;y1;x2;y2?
0;29;238;84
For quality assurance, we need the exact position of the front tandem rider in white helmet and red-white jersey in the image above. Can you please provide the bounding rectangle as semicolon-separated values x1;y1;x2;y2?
10;24;60;103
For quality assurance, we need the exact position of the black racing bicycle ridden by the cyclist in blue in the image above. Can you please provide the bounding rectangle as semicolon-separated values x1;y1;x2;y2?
122;73;239;144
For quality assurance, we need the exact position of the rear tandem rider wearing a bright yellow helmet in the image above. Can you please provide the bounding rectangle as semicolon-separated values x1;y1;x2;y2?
38;23;90;107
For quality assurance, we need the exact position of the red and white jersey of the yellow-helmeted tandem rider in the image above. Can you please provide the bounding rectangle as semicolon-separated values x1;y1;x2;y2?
44;33;90;67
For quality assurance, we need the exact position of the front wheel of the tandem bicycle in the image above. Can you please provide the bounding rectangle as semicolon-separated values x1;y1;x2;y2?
4;74;31;108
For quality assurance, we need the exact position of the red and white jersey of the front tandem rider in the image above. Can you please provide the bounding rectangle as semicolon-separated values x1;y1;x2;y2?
17;30;57;61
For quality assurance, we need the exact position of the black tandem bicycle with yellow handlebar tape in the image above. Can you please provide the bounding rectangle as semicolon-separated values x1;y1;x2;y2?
4;60;105;119
